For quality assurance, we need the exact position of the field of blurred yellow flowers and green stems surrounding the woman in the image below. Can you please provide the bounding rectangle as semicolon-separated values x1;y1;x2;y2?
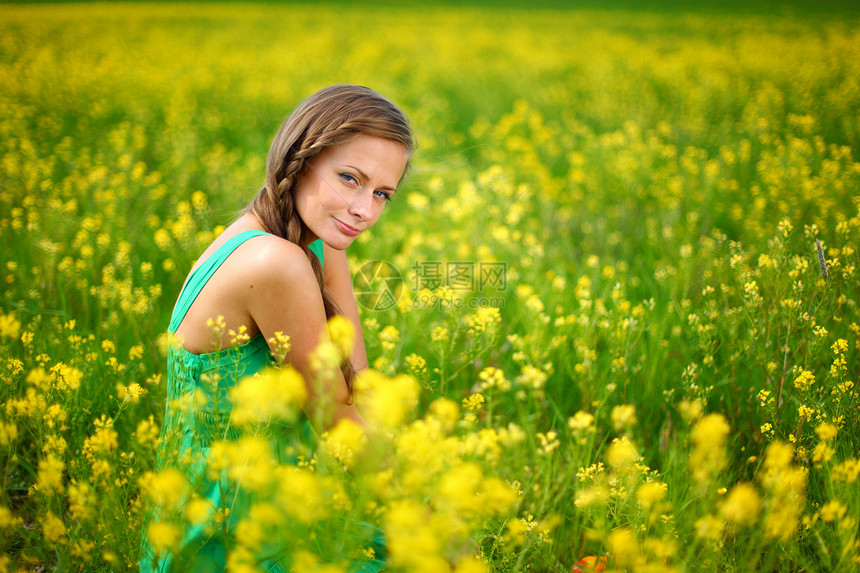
0;1;860;573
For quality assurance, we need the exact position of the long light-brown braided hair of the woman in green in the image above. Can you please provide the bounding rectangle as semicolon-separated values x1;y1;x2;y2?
246;85;415;395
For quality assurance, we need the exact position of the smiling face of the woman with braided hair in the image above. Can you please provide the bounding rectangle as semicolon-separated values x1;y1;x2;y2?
295;135;407;251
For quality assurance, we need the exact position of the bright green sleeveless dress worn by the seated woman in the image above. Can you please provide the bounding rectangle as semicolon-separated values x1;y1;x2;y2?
140;231;386;573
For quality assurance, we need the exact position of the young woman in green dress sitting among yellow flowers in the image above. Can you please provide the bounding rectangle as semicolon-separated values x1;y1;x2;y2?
141;85;414;571
